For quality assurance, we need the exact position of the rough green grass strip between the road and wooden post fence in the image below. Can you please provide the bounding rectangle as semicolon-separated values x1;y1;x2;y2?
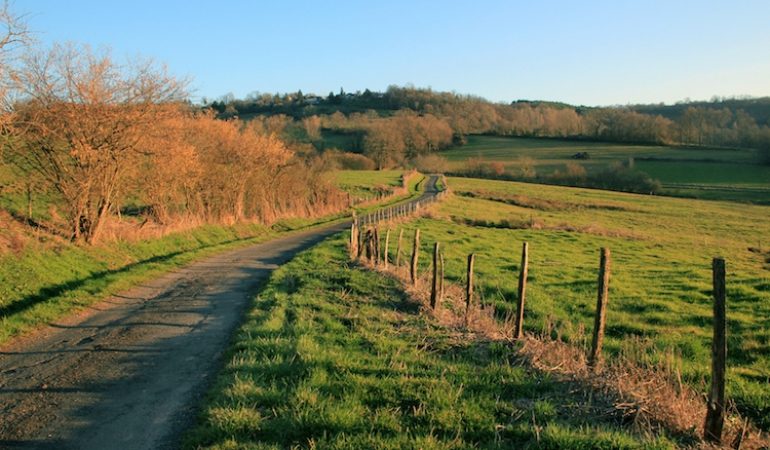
185;237;673;449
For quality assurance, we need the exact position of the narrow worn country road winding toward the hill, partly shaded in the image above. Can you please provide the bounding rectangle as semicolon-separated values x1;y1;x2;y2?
0;176;437;450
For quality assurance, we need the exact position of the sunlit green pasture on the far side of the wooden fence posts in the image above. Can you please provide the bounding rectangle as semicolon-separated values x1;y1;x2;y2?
380;178;770;429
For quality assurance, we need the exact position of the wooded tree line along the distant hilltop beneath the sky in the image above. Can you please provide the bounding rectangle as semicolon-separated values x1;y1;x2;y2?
209;86;770;166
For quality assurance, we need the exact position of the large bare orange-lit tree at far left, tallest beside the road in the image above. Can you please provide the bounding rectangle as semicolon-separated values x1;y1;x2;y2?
12;45;186;243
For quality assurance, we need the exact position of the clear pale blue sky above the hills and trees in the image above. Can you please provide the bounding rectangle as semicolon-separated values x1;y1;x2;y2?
21;0;770;105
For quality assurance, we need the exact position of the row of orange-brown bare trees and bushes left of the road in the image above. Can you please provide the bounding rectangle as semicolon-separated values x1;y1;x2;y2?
5;46;346;243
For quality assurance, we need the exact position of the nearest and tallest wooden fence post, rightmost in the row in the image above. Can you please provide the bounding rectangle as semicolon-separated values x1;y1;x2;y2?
703;258;727;444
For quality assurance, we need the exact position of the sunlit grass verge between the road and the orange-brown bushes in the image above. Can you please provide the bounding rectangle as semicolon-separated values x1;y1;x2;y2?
0;210;343;344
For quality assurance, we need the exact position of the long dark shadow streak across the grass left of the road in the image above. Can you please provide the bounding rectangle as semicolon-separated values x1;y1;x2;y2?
0;238;249;320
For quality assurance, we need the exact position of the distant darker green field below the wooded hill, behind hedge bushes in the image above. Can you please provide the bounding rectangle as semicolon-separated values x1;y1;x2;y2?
441;136;770;203
